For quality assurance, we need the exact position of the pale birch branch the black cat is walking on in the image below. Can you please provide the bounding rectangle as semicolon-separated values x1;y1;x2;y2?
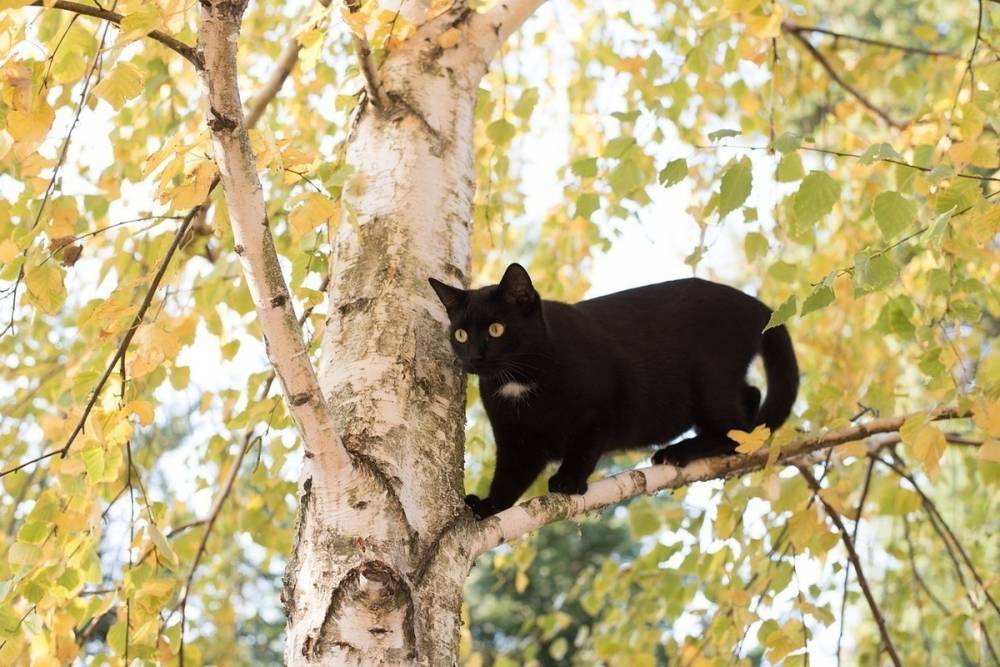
471;408;967;557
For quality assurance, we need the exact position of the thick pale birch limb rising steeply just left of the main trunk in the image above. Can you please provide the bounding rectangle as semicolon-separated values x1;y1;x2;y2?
198;0;351;474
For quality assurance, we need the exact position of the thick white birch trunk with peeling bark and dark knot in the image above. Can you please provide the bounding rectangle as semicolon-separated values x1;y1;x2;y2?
285;9;498;665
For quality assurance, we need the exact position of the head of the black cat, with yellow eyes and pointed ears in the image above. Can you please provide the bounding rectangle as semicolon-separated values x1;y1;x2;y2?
429;264;545;377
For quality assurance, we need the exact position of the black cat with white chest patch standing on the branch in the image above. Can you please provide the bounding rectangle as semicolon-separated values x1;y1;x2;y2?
430;264;799;518
